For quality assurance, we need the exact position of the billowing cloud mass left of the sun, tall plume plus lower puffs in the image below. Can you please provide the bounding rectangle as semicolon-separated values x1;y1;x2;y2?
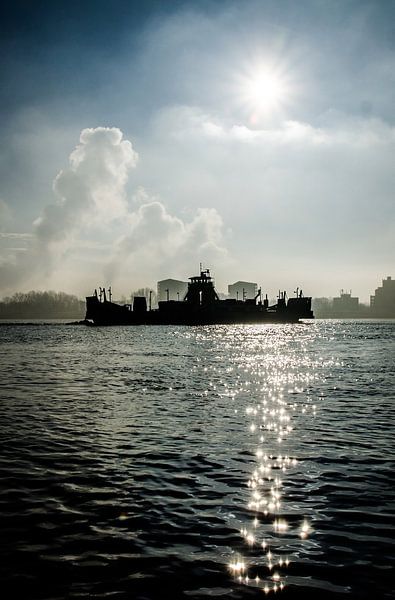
0;127;227;293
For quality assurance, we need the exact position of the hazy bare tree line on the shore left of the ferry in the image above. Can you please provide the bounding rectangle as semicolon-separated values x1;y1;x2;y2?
0;291;85;319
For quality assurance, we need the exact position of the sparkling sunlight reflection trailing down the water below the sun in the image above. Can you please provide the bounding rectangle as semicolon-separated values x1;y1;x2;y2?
227;330;320;594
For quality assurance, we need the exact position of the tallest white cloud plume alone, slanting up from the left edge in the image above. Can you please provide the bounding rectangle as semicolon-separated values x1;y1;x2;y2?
0;127;138;290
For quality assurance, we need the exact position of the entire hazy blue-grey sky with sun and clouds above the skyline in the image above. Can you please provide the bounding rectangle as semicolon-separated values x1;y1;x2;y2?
0;0;395;300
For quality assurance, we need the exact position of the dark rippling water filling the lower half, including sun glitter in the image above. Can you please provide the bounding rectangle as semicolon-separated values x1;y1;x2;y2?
0;321;395;600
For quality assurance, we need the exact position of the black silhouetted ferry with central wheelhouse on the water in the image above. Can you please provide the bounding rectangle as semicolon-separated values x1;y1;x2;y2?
85;269;314;325
